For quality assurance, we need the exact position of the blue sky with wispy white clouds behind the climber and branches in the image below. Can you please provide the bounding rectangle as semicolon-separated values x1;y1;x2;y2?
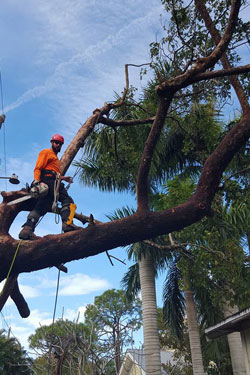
0;0;168;347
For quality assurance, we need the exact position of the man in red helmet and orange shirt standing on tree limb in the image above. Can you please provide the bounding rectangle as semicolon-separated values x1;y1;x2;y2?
19;134;81;240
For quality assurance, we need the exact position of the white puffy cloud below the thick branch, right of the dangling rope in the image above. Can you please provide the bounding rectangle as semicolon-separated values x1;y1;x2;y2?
59;273;110;296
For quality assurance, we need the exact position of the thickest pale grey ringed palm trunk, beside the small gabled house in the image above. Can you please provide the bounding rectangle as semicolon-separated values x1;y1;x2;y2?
139;254;161;375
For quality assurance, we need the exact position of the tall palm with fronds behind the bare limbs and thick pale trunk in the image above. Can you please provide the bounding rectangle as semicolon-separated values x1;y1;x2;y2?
75;80;237;373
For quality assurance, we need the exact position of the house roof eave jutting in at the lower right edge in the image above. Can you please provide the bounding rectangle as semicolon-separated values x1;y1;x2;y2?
205;308;250;339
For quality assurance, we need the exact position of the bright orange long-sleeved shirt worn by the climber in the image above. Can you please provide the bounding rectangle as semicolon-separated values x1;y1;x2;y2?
34;148;60;181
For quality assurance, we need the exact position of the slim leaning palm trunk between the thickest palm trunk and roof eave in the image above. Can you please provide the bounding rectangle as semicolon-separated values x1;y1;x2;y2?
183;271;204;375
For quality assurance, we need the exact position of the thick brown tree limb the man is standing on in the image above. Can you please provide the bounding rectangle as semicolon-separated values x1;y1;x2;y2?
0;116;250;280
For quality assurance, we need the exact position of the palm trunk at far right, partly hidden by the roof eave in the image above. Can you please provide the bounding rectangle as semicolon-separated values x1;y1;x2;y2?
223;302;246;375
